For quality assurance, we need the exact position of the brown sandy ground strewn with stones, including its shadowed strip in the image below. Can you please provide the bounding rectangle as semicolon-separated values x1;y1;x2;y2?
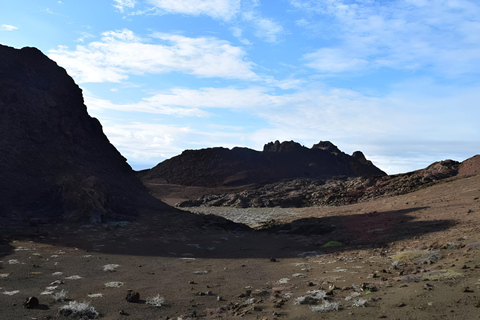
0;175;480;320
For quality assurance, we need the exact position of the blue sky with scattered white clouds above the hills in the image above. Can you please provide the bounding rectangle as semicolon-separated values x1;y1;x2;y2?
0;0;480;174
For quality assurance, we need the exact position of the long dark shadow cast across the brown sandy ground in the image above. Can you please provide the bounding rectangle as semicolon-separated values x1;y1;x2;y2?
0;207;455;259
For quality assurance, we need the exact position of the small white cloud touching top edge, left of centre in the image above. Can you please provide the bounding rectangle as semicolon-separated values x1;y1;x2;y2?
148;0;240;21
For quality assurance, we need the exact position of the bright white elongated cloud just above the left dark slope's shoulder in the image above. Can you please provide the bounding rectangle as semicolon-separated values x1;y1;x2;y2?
49;29;260;83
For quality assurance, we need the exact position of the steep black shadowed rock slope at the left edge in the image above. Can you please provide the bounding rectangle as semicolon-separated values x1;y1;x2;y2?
0;46;166;222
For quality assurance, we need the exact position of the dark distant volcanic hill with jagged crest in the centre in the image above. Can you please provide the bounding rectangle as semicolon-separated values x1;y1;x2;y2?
139;141;385;187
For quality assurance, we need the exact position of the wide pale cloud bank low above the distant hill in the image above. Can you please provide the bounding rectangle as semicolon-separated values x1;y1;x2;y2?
85;79;480;173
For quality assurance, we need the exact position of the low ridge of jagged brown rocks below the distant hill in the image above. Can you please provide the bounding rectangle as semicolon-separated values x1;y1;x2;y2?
178;158;462;208
